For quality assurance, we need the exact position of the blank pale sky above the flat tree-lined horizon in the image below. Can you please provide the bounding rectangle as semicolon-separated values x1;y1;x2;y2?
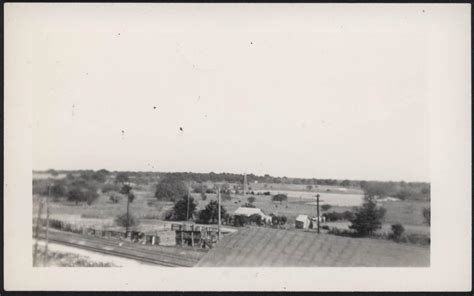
25;5;429;181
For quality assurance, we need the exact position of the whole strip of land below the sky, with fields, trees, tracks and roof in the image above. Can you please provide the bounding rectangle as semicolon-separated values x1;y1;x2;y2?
32;169;430;267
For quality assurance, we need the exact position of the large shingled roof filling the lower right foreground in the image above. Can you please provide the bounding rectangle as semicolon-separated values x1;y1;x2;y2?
197;227;430;267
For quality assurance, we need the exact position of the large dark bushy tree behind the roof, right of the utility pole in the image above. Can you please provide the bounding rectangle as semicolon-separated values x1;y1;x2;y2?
349;198;385;236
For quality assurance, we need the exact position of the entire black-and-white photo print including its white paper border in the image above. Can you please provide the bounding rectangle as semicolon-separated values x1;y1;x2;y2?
4;3;471;290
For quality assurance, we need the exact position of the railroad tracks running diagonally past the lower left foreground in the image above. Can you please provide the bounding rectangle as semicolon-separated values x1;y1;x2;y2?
33;232;206;267
